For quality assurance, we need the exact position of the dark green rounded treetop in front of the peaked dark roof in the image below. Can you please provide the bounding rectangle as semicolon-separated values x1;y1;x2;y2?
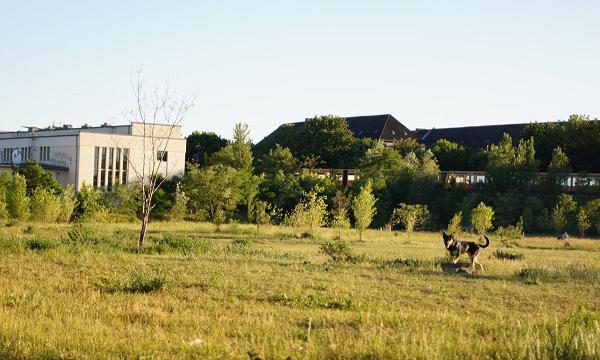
296;115;356;168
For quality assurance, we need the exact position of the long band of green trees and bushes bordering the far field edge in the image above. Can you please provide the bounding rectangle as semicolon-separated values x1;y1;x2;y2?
0;116;600;239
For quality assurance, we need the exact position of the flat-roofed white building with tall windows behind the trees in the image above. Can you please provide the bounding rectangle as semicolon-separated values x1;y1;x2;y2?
0;122;185;190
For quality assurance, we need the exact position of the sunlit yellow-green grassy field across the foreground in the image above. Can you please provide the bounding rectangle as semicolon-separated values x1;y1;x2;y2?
0;223;600;359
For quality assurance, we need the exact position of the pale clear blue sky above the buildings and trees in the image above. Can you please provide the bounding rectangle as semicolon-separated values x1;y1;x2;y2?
0;0;600;142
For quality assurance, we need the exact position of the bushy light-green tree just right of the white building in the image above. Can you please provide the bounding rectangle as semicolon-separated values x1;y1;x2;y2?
182;165;242;222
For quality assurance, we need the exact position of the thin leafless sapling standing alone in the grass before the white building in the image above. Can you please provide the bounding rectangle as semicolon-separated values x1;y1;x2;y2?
126;71;195;249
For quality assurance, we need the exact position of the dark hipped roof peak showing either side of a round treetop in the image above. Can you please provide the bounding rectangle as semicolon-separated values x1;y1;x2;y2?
255;114;416;153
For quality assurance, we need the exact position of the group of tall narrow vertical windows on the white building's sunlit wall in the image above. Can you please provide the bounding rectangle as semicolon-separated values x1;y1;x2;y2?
93;146;129;190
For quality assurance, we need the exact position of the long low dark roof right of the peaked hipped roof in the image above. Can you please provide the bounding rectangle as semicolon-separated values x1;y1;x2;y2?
417;124;529;149
